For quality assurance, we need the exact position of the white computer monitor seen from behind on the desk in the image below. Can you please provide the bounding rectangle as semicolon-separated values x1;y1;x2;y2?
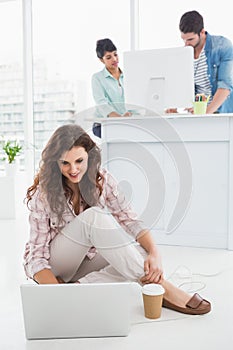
123;46;194;115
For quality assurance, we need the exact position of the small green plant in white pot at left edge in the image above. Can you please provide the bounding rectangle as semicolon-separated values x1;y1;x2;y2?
2;140;22;176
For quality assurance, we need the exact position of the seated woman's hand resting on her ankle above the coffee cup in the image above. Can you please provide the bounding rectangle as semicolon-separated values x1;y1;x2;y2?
141;254;163;284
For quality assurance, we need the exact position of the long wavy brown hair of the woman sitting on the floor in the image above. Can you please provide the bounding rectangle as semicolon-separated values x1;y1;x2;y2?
26;124;103;221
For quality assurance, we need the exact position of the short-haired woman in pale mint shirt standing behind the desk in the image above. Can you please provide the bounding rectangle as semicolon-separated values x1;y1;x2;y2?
92;39;132;137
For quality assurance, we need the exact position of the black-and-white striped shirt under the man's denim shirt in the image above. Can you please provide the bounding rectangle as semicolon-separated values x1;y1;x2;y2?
194;49;212;102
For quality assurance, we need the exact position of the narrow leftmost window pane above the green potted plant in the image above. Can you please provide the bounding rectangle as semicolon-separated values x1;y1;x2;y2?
0;1;24;173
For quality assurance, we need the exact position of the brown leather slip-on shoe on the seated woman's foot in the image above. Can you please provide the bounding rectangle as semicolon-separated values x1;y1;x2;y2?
163;293;211;315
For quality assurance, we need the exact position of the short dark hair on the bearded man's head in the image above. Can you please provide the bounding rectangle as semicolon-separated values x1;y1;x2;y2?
179;11;204;35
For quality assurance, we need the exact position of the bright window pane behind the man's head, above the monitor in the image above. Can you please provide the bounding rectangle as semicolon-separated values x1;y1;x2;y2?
139;0;233;49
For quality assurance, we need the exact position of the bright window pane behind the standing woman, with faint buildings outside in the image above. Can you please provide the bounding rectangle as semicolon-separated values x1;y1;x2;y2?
32;0;130;170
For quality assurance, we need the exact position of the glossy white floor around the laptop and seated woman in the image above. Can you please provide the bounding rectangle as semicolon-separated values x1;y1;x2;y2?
0;202;233;350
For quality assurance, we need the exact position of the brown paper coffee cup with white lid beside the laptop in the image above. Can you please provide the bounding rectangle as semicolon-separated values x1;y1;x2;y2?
142;283;165;319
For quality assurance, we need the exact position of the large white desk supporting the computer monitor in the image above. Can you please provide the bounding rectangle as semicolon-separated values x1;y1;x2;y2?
99;114;233;250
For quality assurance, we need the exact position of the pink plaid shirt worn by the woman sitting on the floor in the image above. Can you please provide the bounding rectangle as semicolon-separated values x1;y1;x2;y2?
24;169;144;278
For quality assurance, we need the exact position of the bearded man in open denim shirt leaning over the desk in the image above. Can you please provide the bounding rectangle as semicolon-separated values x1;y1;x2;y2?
179;11;233;114
